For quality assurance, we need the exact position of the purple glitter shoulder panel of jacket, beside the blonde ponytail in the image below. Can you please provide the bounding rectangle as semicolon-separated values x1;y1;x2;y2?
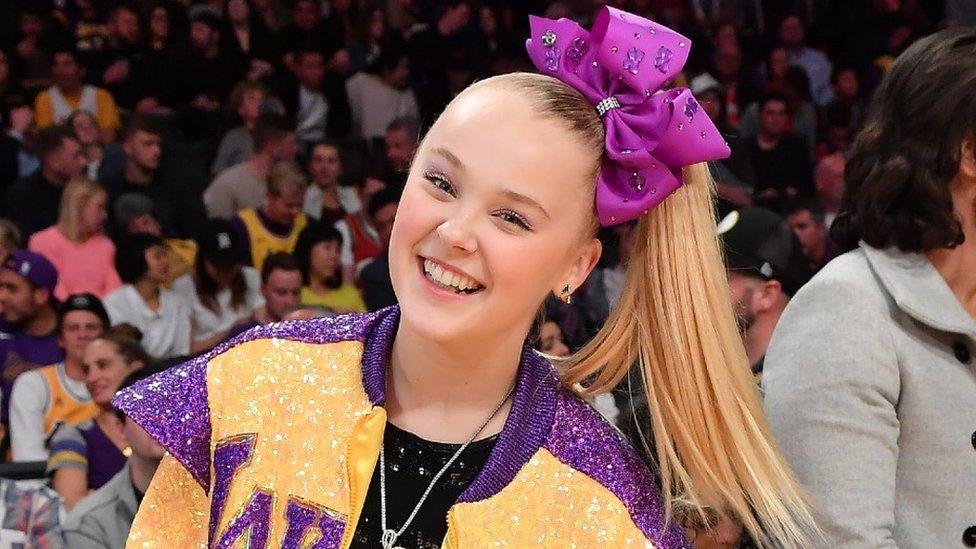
546;389;691;549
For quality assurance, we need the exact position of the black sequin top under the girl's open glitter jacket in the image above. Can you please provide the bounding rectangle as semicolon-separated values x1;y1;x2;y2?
351;423;498;549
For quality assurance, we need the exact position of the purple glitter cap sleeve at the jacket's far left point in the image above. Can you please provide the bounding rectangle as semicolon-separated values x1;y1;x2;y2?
112;356;210;491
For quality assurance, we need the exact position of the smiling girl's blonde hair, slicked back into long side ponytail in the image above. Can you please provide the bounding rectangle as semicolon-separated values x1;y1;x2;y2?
479;73;816;547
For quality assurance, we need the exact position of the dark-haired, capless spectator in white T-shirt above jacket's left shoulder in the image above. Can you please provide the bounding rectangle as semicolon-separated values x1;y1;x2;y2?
104;233;192;358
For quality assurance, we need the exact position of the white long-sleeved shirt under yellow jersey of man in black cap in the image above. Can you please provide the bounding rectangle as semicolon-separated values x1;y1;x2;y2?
10;362;91;461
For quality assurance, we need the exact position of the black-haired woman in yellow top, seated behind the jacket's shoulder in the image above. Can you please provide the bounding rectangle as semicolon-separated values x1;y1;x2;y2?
295;223;366;312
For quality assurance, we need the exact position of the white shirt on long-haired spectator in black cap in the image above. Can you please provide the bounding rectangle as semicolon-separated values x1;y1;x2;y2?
173;267;264;341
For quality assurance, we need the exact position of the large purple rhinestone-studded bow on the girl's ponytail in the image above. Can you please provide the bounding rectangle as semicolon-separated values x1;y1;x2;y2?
526;7;730;227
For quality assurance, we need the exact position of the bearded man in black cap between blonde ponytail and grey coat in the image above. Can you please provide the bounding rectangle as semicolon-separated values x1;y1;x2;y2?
718;208;810;380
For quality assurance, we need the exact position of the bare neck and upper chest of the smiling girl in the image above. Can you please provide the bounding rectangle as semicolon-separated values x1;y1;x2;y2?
386;322;524;443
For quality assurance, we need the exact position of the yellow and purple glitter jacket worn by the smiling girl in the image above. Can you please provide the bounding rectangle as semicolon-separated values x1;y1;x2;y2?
115;307;688;549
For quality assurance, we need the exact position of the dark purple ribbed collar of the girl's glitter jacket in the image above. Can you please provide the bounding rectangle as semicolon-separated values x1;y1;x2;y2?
363;306;559;503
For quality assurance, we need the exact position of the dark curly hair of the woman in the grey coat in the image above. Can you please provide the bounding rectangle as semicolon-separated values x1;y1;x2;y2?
831;27;976;253
